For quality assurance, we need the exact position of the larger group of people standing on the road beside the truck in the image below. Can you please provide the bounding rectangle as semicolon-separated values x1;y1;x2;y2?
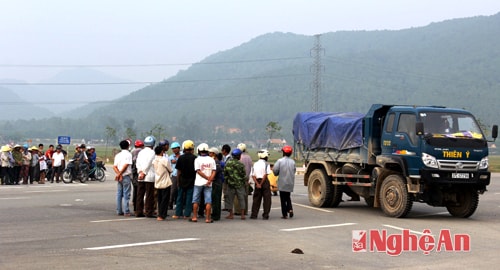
113;136;296;223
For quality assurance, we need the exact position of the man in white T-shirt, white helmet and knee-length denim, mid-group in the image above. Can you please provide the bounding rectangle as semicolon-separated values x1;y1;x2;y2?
190;143;216;223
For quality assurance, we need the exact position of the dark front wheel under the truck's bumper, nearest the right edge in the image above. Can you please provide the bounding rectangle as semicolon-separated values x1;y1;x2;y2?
446;188;479;218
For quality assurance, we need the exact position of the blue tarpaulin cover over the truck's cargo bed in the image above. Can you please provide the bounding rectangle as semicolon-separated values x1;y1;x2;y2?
293;112;365;150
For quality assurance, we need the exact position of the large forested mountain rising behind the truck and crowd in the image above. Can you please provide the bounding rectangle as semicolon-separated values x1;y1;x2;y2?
0;13;500;142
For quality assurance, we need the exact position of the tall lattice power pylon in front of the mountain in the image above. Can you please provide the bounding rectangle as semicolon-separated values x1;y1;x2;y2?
311;34;325;112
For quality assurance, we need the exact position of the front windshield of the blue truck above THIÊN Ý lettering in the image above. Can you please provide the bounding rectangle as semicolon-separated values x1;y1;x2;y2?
420;112;483;139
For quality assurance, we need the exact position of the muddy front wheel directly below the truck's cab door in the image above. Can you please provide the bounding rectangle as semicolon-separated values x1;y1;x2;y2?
379;174;413;218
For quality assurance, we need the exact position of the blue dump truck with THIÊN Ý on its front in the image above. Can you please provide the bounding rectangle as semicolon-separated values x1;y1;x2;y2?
293;104;498;218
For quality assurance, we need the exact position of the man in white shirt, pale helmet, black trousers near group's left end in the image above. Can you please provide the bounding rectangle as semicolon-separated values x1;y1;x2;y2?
135;136;156;218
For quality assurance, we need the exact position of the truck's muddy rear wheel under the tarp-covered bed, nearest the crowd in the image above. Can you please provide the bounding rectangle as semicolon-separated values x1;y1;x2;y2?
307;169;342;207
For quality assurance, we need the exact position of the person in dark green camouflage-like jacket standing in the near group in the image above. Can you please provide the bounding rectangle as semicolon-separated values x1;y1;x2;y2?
224;148;248;219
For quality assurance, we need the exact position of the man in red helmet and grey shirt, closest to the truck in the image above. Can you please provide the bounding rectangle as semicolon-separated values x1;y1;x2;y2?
273;145;296;219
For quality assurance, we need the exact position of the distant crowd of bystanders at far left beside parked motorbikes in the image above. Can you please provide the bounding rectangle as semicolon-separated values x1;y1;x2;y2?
0;144;96;185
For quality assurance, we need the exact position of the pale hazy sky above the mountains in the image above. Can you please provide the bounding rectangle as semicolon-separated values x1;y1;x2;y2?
0;0;500;82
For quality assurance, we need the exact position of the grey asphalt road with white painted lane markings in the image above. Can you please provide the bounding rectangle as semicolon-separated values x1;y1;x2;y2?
0;170;500;269
